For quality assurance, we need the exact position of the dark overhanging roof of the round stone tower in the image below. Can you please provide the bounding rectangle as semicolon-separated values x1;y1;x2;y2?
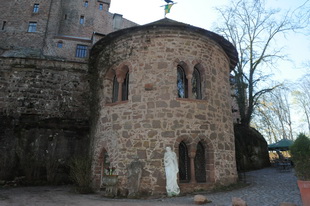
90;18;239;70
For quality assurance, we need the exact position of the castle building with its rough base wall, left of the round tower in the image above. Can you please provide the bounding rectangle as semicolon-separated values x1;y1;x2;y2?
0;0;137;184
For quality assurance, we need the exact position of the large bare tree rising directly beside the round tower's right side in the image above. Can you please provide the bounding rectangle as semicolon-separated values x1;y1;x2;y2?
215;0;300;126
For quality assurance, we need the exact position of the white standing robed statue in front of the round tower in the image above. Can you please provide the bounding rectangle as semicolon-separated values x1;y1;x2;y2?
164;147;180;197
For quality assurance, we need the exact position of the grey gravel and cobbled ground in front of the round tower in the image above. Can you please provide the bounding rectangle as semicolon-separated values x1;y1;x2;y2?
0;168;302;206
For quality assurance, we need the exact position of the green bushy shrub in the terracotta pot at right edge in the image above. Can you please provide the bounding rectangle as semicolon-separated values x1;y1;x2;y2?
290;133;310;180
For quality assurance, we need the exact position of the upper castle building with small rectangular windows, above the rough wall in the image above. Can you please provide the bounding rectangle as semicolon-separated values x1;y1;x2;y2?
0;0;137;62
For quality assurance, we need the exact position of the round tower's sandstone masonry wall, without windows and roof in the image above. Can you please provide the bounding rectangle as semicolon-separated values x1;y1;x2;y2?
91;25;237;193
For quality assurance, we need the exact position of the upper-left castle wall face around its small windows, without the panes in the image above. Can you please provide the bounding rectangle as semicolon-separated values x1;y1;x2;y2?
0;0;51;51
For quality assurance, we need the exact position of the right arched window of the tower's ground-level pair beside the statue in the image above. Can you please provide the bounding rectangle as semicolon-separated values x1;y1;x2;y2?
194;142;206;182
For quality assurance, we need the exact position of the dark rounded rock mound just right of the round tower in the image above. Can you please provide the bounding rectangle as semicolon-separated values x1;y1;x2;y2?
234;125;270;171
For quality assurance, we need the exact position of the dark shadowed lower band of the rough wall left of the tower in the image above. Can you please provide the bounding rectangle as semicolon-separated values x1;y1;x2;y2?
0;115;89;185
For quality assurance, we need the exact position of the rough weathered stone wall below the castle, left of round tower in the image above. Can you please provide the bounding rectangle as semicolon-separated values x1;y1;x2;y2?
0;58;89;184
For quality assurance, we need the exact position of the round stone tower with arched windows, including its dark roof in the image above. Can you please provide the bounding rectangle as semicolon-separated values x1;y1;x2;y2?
89;19;238;194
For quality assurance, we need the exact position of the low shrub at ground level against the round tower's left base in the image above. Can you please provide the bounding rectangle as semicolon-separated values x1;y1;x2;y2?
69;157;93;194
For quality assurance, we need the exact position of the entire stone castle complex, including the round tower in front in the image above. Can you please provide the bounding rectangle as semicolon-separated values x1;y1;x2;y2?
0;0;238;195
